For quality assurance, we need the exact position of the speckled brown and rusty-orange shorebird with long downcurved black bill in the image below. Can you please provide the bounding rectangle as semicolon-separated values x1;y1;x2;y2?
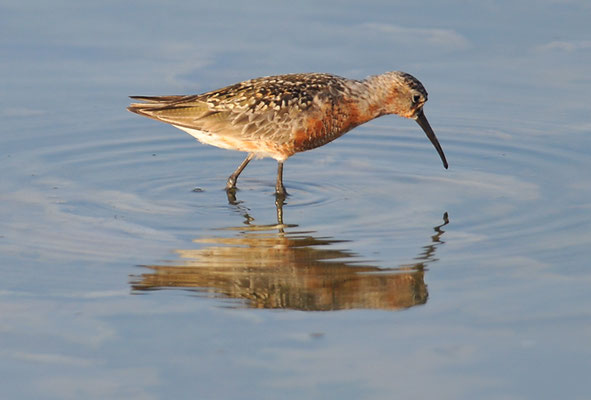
127;71;447;196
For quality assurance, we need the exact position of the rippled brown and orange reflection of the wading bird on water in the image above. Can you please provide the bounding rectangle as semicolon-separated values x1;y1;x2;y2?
131;193;448;311
